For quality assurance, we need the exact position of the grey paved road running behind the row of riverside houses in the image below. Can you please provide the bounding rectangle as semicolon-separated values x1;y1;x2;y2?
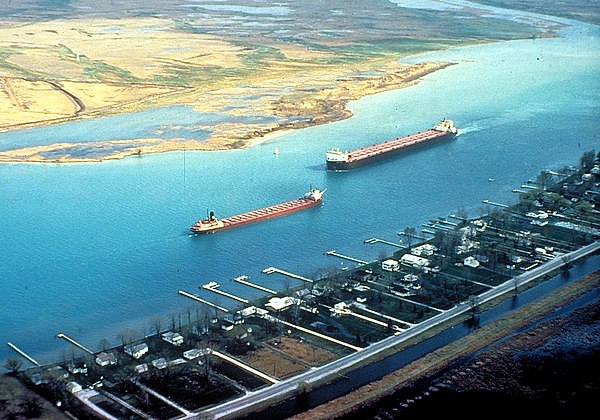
198;242;600;418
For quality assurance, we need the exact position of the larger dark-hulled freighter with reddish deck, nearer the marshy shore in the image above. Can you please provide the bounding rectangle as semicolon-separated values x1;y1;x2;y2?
326;118;458;171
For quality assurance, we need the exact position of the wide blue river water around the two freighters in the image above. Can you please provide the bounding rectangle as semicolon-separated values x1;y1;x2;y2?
0;18;600;361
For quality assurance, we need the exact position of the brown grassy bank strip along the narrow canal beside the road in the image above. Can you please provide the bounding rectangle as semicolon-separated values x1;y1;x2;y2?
293;272;600;420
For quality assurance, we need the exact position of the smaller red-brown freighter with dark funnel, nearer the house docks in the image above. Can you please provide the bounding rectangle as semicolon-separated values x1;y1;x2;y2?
190;188;325;233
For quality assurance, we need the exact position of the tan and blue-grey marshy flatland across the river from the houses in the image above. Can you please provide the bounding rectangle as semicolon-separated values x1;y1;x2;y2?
0;2;557;163
